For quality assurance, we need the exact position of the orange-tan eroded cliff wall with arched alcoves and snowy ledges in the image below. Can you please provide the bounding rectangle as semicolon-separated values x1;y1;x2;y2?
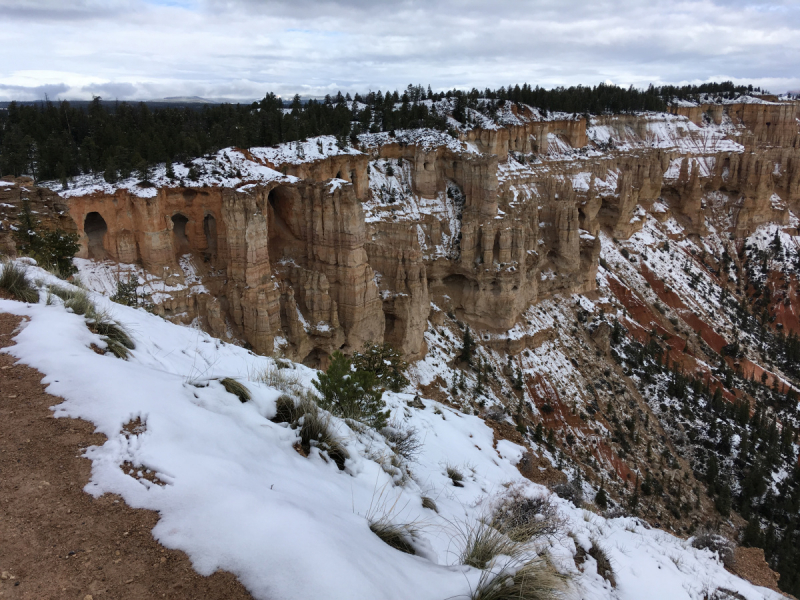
7;95;800;365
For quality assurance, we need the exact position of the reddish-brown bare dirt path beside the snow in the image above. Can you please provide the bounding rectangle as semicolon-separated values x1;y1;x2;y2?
0;313;251;600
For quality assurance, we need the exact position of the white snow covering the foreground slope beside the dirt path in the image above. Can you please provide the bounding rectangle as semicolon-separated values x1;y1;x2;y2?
0;267;780;600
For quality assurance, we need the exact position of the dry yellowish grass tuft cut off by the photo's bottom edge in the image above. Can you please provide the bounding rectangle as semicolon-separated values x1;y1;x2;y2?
471;556;569;600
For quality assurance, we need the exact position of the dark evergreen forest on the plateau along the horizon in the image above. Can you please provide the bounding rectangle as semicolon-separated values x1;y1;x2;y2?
0;82;760;182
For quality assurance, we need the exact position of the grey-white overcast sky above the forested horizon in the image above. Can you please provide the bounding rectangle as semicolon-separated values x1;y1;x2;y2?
0;0;800;100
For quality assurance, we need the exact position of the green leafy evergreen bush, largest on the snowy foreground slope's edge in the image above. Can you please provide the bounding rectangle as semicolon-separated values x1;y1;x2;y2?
314;352;389;429
